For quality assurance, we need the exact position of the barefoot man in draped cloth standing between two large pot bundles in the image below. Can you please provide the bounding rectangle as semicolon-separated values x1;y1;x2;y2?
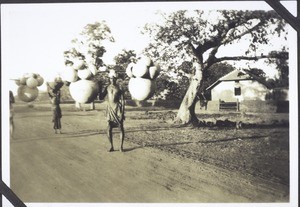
101;70;125;152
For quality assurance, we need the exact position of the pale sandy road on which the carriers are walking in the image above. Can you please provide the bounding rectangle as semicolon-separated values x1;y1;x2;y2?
10;102;289;203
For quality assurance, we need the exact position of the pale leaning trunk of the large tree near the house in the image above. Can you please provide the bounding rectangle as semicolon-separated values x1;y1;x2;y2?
175;63;202;124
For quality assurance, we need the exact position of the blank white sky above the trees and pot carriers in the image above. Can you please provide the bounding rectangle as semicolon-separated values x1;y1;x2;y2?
1;2;296;93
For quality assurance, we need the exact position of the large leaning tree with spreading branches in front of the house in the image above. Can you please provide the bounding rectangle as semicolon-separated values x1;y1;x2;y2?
144;10;288;123
